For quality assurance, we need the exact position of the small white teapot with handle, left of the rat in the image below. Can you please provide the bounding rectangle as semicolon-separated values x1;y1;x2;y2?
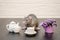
6;21;21;33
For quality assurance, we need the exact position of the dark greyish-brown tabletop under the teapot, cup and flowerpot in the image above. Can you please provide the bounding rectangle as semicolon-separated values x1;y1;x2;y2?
0;18;60;40
